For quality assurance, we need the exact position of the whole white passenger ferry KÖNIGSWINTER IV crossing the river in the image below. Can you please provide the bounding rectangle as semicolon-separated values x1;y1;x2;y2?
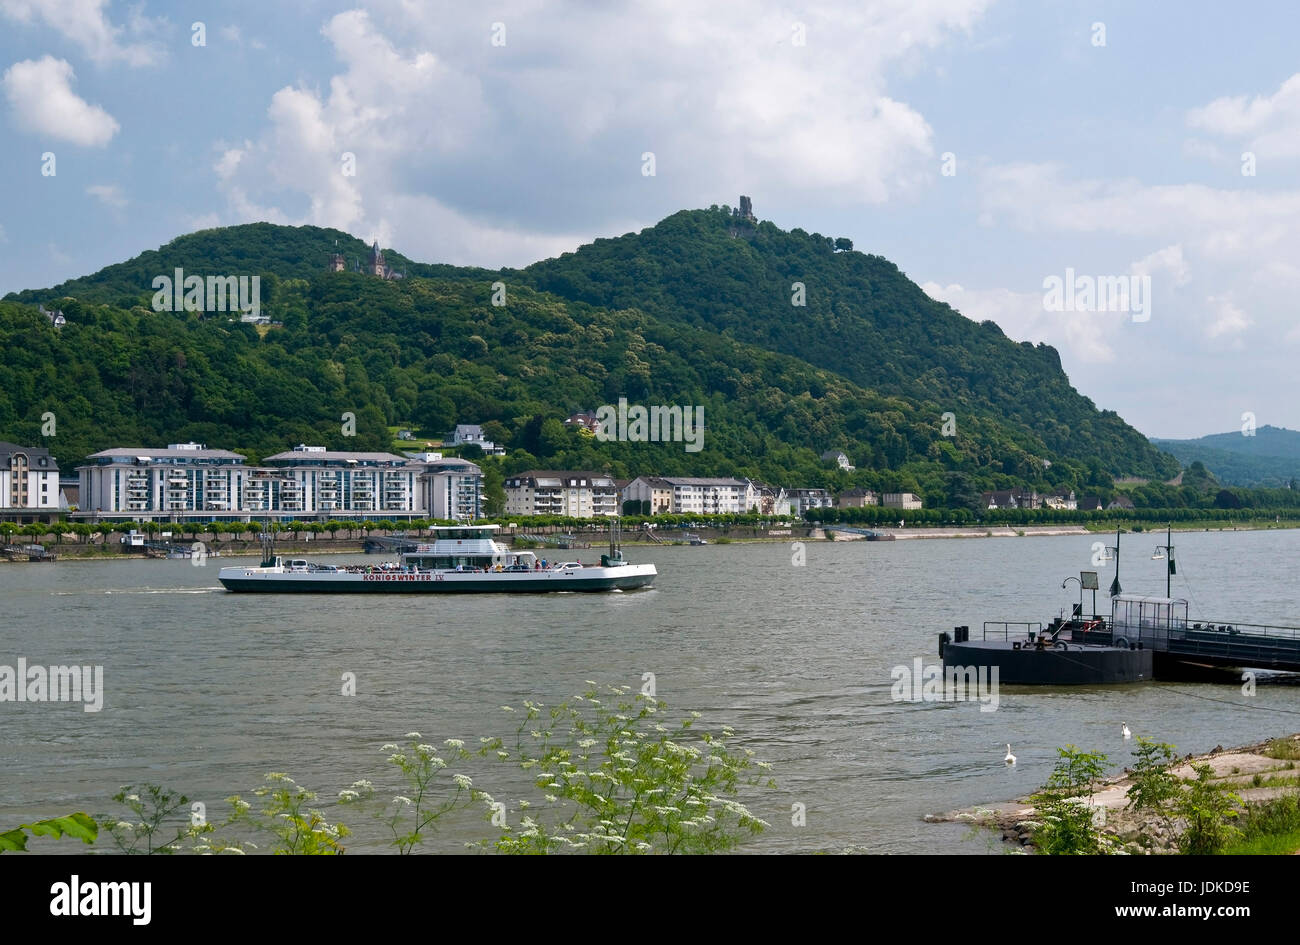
217;524;658;594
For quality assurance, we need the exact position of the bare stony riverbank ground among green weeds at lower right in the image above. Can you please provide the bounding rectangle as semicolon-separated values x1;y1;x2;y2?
924;734;1300;855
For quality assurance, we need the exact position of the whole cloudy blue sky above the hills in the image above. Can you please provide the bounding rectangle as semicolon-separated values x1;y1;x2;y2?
0;0;1300;437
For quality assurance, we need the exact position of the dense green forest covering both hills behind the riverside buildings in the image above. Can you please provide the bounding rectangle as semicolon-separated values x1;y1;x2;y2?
0;208;1178;508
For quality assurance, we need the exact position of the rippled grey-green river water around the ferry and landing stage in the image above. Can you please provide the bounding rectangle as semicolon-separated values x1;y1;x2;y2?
0;530;1300;854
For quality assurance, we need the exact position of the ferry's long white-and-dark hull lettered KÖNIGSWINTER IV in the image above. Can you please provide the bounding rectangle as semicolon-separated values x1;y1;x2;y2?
218;564;657;594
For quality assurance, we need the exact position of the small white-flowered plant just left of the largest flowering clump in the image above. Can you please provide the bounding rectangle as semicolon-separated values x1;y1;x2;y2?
338;732;475;855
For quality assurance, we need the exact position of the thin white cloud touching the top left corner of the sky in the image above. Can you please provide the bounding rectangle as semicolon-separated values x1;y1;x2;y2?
0;0;166;66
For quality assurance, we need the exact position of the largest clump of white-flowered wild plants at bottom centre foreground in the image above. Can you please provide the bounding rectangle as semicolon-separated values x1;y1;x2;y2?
477;681;776;854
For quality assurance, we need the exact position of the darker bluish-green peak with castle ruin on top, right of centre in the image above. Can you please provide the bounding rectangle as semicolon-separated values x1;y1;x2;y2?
523;207;1178;477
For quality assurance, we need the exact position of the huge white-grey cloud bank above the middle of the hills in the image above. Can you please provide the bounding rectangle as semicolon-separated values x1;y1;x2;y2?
216;0;988;266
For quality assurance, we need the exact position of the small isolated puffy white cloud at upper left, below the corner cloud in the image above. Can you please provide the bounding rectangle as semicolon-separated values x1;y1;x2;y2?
0;56;120;147
